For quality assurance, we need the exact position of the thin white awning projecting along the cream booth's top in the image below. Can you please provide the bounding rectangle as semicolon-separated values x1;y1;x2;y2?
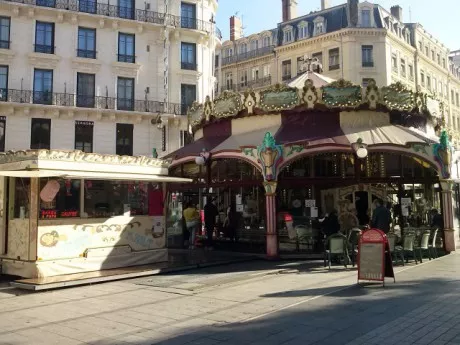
0;170;192;183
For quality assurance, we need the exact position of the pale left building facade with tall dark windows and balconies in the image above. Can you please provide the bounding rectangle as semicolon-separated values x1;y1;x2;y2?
0;0;221;156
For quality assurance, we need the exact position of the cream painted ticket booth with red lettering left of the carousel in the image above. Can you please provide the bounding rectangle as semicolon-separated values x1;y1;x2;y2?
0;150;191;278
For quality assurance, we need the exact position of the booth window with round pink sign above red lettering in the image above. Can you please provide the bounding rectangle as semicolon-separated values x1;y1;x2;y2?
39;178;81;219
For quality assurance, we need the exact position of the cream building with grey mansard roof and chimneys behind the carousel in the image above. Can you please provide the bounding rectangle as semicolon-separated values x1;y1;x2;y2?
216;0;460;143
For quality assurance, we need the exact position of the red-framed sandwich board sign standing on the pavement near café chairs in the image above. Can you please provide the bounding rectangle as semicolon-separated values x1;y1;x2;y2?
358;229;396;286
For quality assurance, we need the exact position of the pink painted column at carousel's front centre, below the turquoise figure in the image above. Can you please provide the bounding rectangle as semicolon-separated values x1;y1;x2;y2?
264;182;279;259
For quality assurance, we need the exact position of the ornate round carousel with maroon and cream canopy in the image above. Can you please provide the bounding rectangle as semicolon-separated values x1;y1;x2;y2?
168;79;458;257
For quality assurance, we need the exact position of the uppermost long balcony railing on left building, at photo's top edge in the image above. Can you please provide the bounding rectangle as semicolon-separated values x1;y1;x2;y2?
2;0;212;32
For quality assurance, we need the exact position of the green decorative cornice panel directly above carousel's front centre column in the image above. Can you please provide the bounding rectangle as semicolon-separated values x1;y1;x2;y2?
260;85;299;111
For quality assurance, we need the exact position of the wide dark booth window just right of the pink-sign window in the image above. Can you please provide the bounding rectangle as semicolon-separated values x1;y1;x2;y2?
85;180;148;218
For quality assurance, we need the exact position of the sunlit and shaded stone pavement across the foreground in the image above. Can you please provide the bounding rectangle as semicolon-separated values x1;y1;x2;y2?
0;254;460;345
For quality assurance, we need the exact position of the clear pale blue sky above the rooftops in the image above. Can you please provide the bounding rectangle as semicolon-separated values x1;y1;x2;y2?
217;0;460;50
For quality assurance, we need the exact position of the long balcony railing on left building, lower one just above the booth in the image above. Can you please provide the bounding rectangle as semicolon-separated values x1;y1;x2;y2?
0;89;186;115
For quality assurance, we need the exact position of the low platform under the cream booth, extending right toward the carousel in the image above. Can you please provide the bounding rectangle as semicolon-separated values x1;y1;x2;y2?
10;249;261;291
